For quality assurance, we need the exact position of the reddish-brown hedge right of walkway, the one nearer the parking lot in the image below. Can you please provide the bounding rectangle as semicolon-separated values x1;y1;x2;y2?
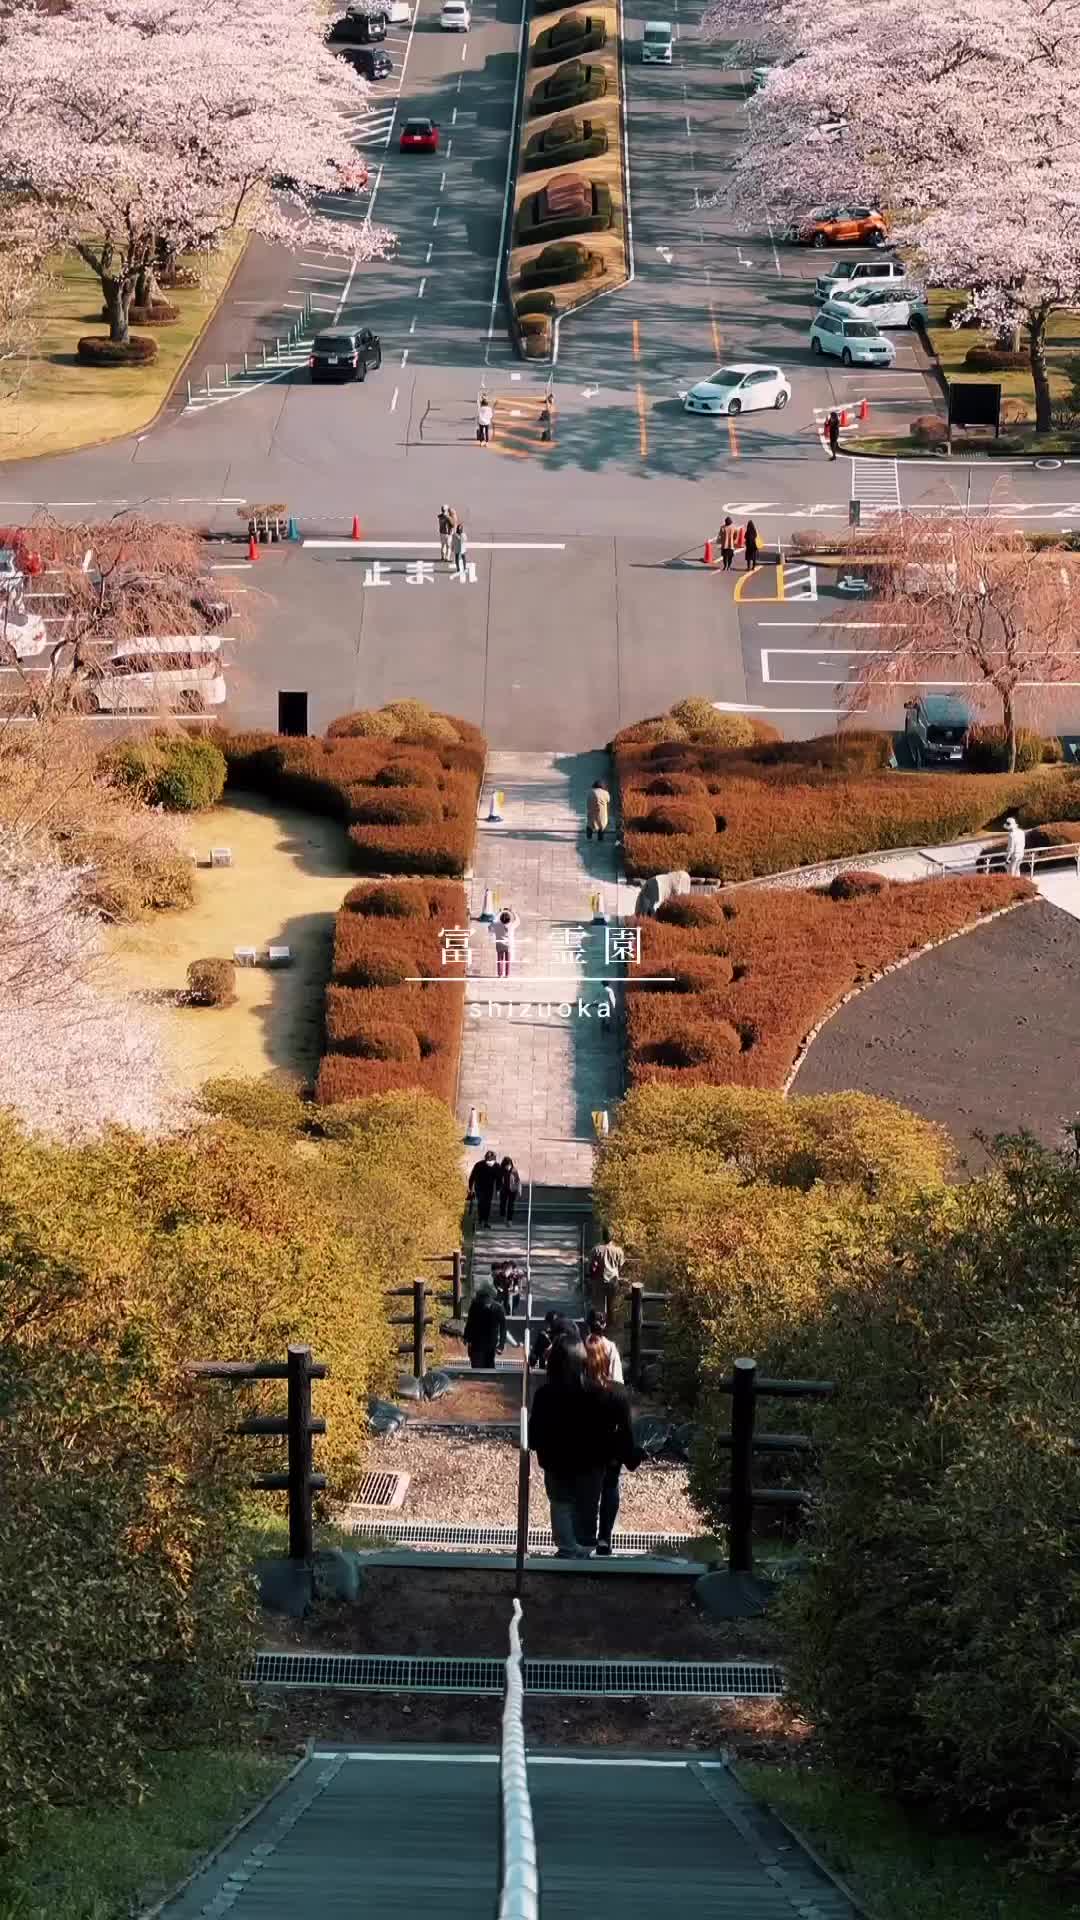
613;718;1080;881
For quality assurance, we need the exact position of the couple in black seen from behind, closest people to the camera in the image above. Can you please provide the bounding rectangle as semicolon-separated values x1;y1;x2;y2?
528;1308;644;1559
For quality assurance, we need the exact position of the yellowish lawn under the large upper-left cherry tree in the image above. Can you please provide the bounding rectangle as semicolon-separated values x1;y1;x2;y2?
0;234;244;461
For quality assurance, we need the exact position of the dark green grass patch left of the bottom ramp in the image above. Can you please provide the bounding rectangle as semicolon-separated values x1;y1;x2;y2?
0;1747;290;1920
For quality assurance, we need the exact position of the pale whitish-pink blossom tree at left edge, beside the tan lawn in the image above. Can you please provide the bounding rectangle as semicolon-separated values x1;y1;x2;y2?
0;828;190;1140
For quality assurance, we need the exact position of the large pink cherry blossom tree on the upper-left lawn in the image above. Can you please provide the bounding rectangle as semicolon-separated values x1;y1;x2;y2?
0;0;392;342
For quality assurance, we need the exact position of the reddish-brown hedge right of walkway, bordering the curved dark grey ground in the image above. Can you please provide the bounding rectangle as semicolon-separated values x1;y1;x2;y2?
626;874;1034;1087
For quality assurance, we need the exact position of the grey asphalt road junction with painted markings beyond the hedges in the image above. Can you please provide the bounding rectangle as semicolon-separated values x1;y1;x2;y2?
0;0;1080;747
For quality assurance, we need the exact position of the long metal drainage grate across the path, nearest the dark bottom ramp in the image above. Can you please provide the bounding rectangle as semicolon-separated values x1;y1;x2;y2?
242;1653;784;1699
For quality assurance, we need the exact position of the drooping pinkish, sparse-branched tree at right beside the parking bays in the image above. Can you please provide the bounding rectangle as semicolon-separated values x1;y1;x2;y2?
846;513;1080;772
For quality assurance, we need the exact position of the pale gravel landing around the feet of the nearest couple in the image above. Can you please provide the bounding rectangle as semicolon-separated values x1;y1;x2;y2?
357;1428;707;1534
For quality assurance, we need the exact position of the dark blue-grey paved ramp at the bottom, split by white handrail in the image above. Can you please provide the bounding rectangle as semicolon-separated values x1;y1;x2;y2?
163;1747;857;1920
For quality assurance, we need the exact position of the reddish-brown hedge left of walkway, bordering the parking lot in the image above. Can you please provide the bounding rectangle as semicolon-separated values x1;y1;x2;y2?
215;701;486;877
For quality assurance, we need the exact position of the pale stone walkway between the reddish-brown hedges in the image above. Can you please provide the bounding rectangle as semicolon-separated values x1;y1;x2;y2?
457;753;630;1188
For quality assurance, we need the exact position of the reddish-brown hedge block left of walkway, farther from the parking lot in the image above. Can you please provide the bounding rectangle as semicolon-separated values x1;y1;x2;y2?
315;879;469;1104
